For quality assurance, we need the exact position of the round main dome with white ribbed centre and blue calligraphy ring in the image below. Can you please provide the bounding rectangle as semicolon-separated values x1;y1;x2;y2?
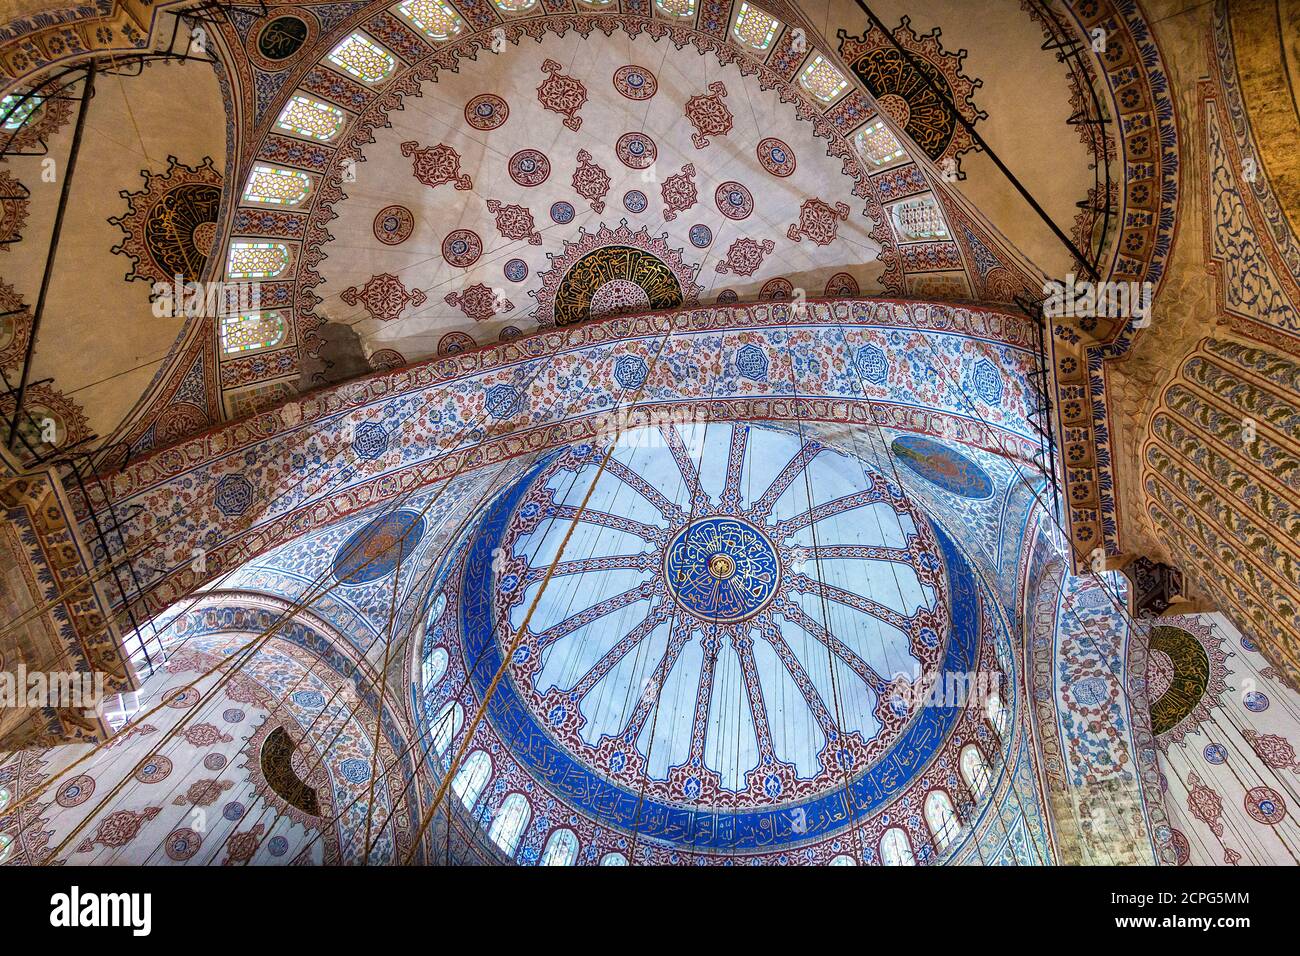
423;421;997;860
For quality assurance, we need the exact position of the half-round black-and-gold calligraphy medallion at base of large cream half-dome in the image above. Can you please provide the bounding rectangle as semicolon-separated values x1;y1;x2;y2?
529;220;702;328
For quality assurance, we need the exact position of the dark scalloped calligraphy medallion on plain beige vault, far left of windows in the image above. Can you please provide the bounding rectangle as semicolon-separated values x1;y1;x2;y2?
108;156;221;284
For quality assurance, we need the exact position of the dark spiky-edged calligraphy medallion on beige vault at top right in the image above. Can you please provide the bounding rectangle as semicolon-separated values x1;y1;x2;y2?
837;17;988;163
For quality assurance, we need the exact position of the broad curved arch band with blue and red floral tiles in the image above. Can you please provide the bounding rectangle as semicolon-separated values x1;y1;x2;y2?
74;299;1039;621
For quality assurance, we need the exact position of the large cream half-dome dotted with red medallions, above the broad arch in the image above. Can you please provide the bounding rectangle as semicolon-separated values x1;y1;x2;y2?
316;33;884;359
